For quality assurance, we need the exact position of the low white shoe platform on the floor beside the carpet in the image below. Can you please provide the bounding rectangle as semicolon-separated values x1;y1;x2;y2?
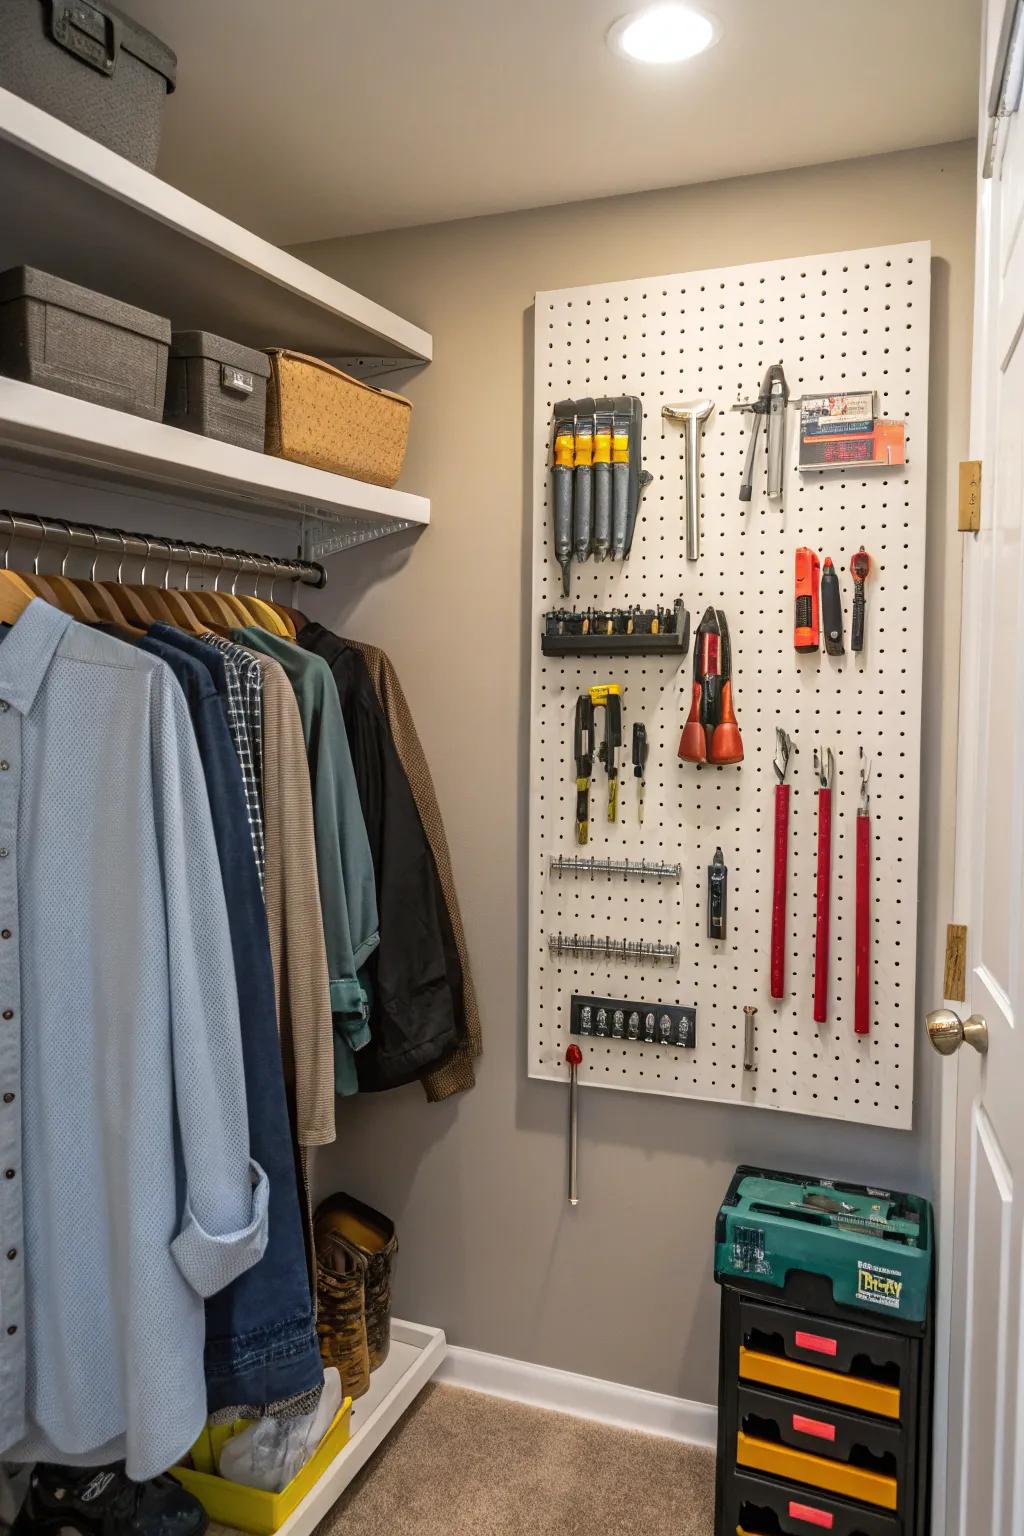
268;1318;448;1536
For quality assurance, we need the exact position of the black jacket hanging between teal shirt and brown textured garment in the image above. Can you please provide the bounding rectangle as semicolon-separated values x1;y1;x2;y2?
298;624;464;1092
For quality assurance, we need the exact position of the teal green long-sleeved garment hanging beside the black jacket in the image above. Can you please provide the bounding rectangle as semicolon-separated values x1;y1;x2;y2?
232;625;379;1094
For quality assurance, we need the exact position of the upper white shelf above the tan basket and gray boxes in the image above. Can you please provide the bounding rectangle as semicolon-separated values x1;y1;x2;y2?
0;89;431;362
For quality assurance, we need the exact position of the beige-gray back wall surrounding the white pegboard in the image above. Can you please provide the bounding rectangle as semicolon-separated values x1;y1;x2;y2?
302;144;975;1401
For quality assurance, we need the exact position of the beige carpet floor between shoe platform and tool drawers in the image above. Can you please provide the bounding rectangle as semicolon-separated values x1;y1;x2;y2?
318;1384;714;1536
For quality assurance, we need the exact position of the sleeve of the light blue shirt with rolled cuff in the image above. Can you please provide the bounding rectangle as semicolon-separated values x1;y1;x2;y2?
152;673;267;1296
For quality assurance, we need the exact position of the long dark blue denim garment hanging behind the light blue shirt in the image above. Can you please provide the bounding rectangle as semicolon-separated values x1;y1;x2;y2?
138;624;324;1419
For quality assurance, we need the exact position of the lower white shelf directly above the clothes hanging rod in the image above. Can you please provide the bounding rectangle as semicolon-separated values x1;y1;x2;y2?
0;378;430;559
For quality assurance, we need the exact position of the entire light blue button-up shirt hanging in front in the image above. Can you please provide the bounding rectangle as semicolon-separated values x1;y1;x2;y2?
0;601;267;1479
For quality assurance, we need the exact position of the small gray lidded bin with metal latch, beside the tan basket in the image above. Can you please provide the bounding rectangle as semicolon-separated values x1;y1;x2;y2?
164;330;270;453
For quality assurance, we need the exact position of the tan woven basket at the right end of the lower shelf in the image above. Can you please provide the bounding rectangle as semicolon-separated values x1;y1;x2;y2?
266;350;413;485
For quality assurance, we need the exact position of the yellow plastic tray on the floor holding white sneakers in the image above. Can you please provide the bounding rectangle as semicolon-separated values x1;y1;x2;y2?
170;1398;352;1536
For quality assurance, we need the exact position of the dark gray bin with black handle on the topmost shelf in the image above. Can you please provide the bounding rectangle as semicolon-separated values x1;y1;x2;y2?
0;0;178;170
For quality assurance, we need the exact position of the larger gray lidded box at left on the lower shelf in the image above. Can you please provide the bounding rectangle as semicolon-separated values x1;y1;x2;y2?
0;267;170;421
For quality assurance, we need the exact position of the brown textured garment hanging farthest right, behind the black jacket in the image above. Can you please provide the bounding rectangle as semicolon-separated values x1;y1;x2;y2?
333;624;484;1103
